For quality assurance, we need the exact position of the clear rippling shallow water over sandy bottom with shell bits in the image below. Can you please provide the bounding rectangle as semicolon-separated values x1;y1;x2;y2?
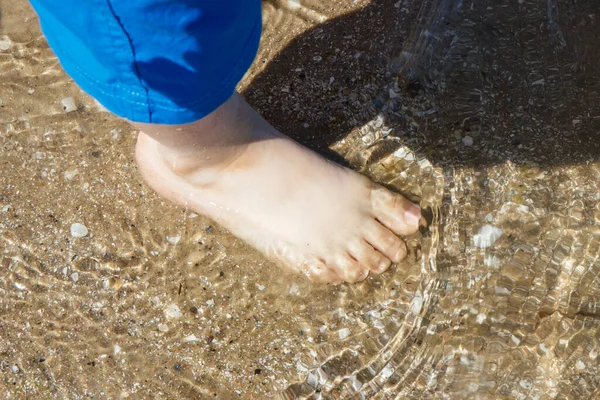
0;0;600;399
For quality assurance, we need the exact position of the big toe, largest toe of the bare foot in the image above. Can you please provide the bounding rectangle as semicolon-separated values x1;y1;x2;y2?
371;187;425;235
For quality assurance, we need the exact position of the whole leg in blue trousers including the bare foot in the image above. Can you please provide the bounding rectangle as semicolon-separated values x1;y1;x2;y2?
32;0;421;282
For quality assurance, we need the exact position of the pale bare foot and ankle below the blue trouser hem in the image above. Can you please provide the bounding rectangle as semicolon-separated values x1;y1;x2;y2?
135;94;423;283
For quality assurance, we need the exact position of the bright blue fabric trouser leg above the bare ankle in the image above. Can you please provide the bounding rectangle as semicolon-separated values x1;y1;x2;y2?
31;0;262;124
